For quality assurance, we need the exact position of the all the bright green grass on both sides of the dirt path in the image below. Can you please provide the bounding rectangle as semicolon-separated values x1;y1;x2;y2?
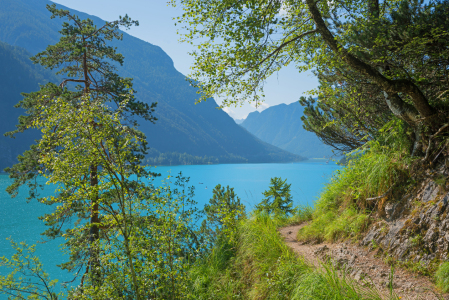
189;121;430;300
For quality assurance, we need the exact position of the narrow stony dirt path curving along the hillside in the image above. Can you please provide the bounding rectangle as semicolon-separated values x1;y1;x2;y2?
279;225;449;300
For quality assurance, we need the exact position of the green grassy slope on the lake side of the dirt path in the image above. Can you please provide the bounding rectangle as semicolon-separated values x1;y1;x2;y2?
186;215;396;300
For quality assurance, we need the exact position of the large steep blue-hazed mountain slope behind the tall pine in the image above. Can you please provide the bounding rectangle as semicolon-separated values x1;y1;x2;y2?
0;0;302;164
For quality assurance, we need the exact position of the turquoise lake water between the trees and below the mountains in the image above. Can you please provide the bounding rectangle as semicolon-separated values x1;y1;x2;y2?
0;160;339;299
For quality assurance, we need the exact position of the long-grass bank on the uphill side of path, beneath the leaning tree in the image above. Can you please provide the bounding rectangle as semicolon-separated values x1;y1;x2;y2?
298;127;411;241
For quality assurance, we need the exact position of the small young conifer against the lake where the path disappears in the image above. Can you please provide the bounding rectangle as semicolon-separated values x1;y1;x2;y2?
256;177;293;214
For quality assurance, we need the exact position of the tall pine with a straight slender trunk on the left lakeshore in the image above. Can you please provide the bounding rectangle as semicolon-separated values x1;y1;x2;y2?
6;4;156;285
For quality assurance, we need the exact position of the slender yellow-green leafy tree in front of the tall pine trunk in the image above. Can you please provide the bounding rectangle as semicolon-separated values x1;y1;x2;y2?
33;95;149;299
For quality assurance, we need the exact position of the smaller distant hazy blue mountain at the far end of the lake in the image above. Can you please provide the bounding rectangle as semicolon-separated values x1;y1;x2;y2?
240;102;333;158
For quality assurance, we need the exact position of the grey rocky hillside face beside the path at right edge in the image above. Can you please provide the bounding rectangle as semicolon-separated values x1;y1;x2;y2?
361;168;449;268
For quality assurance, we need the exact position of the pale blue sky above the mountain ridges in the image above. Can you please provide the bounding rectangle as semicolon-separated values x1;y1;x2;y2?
52;0;318;119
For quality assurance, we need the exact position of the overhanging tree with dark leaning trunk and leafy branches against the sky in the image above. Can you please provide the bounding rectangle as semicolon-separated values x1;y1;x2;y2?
171;0;449;159
